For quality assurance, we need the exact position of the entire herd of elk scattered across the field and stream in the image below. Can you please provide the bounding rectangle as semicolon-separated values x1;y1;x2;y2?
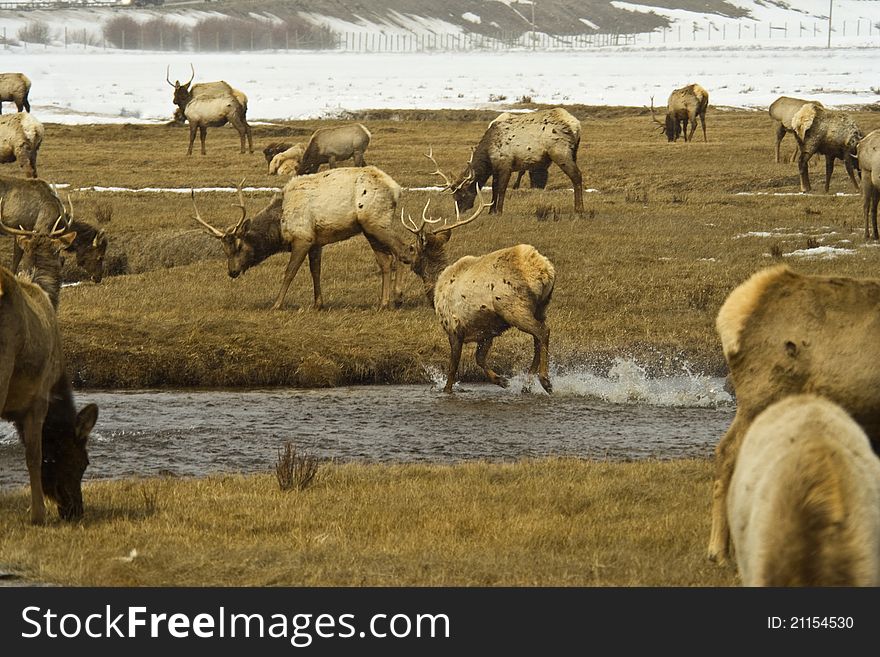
0;69;880;585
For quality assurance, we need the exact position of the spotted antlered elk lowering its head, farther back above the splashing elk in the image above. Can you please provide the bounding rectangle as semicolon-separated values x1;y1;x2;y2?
444;107;584;214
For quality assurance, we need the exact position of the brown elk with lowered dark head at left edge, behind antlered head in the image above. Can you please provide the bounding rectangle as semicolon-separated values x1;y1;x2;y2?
0;176;108;283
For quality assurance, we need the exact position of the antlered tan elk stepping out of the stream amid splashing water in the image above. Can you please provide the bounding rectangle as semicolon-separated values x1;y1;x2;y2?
400;188;556;392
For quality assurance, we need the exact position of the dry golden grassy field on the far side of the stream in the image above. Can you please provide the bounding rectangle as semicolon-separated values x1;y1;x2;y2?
0;107;880;388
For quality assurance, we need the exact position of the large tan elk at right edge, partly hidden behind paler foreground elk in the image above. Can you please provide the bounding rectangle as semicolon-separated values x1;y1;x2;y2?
708;266;880;562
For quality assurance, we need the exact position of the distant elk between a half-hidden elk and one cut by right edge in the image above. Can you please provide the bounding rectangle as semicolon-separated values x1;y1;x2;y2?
791;103;862;194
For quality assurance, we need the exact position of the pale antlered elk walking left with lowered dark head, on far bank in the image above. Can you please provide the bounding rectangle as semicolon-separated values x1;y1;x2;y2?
193;166;409;310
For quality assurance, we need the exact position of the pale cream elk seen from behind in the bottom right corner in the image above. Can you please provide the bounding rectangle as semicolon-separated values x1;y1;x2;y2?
727;395;880;586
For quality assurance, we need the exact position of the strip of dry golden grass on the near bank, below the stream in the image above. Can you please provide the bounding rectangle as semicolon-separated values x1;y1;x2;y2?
0;459;736;586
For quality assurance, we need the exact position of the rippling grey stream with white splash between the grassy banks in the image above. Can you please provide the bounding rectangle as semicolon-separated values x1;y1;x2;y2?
0;360;735;488
